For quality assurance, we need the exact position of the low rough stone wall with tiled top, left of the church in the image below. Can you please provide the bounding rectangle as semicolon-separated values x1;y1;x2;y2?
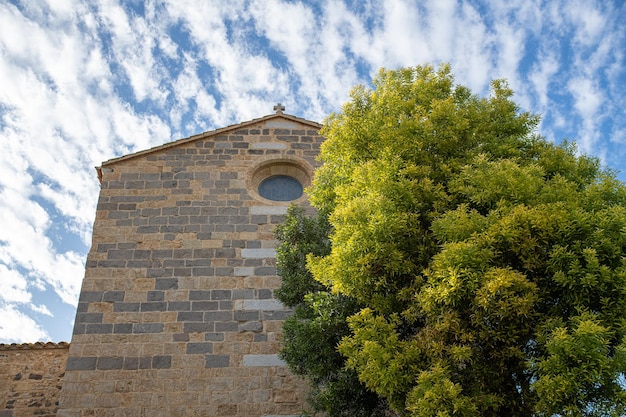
0;343;68;417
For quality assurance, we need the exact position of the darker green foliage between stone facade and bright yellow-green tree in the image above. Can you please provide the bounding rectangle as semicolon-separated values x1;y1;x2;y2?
276;206;387;417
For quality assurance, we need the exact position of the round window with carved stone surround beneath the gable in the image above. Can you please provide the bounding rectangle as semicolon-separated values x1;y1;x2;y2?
246;156;313;205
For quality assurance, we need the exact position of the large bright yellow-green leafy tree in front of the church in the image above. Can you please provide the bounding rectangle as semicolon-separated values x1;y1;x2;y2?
276;65;626;417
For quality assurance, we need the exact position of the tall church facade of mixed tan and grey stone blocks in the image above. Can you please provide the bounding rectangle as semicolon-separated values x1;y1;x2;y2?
58;111;323;417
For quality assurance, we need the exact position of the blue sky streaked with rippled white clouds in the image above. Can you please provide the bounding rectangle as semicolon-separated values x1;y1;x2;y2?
0;0;626;343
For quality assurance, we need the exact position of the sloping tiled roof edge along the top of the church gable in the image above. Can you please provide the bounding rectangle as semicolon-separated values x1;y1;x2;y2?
96;110;322;171
